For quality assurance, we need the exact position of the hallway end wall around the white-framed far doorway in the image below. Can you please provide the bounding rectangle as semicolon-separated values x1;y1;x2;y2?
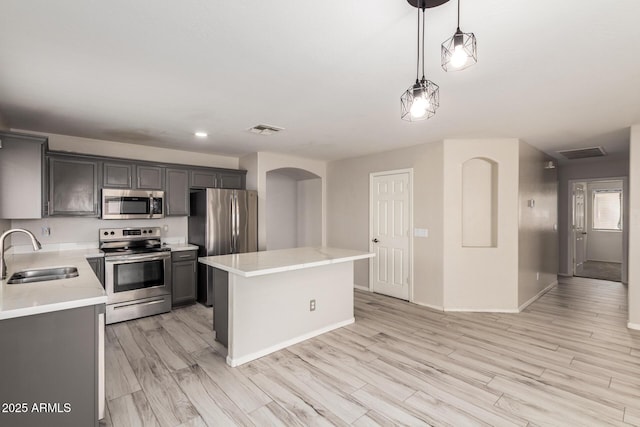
558;156;629;281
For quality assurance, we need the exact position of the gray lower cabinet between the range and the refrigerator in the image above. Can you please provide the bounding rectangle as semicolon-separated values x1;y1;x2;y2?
171;250;198;307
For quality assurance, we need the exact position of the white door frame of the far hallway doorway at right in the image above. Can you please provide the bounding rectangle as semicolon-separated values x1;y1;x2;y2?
565;176;629;283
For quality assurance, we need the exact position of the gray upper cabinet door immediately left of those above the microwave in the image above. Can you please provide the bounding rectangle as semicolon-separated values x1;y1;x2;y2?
48;156;99;216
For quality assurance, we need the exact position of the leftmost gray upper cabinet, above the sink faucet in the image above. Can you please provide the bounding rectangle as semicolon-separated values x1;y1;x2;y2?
0;132;47;219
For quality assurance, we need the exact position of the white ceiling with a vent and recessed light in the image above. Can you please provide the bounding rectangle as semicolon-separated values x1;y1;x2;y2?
0;0;640;160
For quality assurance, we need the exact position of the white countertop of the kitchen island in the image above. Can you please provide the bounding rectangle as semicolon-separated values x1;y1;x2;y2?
198;246;375;277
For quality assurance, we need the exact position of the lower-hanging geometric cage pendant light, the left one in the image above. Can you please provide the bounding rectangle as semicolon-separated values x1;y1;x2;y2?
400;0;440;122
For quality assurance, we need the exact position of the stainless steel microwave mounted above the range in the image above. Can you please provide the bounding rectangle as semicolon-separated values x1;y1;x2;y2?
102;188;164;219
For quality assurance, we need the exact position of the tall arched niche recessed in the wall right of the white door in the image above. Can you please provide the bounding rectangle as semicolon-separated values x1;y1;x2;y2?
462;157;499;248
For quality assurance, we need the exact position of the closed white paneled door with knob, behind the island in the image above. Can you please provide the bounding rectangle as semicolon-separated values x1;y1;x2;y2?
369;171;412;300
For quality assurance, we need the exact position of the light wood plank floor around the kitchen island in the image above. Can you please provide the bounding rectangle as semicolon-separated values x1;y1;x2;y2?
103;278;640;427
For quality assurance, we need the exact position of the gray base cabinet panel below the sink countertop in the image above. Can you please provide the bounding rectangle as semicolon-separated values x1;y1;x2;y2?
0;304;104;427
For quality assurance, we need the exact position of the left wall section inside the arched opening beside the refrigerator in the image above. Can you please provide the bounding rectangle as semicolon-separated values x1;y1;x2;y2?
266;171;298;250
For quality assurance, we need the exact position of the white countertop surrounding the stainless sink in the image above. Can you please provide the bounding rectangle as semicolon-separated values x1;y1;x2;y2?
0;249;107;320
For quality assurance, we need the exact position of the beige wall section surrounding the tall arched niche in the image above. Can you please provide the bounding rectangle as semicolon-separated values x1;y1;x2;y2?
443;139;519;311
